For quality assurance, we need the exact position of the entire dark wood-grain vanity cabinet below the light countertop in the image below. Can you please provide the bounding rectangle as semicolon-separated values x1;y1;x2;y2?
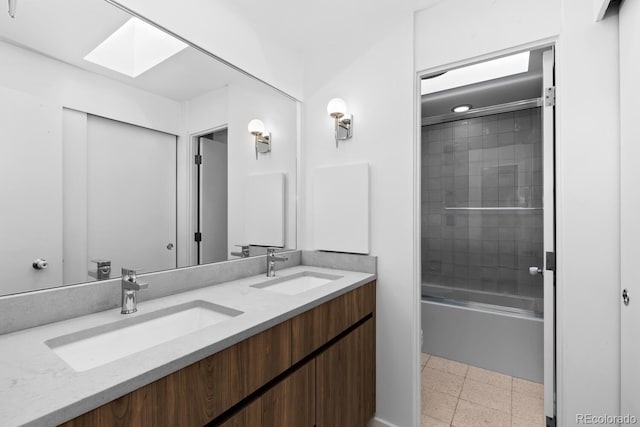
62;281;376;427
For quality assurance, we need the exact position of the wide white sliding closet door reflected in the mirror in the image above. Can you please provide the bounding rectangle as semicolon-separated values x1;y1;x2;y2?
87;115;177;277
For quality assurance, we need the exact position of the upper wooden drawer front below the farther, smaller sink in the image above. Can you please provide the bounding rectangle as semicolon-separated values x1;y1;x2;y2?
291;281;376;363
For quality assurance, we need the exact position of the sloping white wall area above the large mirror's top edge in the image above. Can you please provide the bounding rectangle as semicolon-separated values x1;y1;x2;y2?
112;0;302;99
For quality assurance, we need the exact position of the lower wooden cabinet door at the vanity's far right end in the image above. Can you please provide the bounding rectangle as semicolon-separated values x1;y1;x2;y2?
316;317;376;427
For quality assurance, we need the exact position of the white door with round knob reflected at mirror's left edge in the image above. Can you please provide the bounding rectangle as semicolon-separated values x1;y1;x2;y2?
0;87;62;295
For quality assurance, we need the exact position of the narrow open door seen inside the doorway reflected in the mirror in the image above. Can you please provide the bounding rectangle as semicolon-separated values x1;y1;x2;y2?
200;131;228;264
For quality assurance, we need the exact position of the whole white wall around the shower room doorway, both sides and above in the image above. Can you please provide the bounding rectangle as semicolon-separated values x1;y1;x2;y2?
300;0;619;426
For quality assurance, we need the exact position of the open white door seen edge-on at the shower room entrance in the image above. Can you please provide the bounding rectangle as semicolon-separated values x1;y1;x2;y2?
542;49;556;419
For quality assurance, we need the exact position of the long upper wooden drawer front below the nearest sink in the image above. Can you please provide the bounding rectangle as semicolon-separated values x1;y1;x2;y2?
62;321;291;427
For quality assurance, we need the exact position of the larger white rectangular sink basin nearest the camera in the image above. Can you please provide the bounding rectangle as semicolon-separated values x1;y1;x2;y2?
45;300;242;372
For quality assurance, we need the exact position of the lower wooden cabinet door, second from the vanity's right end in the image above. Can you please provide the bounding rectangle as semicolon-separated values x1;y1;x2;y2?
262;360;316;427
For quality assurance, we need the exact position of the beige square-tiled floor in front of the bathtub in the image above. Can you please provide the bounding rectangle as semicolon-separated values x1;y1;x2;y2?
422;353;545;427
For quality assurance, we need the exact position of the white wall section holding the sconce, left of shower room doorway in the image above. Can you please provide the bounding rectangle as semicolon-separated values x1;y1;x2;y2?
299;8;420;426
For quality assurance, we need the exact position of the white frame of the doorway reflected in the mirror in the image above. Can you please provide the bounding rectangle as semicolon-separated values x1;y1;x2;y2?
187;123;229;266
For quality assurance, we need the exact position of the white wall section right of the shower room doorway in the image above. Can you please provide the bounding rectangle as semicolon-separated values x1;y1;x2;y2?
557;0;620;426
